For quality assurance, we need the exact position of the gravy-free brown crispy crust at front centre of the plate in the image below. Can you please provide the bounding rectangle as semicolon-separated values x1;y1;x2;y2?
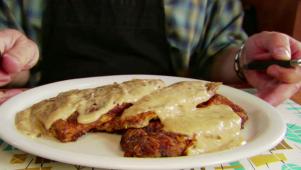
120;121;193;157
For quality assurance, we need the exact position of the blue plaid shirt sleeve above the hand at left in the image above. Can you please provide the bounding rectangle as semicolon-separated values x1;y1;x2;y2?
0;0;44;44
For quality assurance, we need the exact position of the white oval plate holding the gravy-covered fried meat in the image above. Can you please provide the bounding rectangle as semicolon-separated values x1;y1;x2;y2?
0;75;286;170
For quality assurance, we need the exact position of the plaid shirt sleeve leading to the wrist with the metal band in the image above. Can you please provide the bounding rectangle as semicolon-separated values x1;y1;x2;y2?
190;0;247;79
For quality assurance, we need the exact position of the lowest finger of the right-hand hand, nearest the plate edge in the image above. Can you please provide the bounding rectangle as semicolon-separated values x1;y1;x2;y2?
256;83;301;106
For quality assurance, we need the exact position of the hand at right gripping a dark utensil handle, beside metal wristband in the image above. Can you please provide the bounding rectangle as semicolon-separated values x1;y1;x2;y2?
241;32;301;106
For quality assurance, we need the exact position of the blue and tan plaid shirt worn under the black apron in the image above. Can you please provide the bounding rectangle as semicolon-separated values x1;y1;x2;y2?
0;0;246;78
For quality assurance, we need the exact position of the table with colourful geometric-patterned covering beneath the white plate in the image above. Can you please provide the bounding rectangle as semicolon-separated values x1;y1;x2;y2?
0;91;301;170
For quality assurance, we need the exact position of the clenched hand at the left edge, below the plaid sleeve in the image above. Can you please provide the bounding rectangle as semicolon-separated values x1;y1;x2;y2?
0;29;39;87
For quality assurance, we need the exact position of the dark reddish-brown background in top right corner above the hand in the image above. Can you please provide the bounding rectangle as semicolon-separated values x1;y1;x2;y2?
242;0;301;41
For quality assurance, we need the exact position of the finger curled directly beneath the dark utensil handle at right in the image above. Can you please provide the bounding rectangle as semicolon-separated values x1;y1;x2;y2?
266;65;301;83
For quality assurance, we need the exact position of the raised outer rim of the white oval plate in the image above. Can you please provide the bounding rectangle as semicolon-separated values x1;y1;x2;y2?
0;74;286;169
